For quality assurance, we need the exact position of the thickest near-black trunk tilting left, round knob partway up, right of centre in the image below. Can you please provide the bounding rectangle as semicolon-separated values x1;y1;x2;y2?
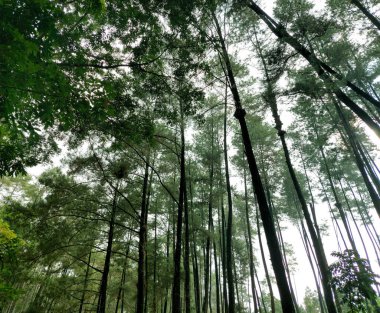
213;15;295;313
